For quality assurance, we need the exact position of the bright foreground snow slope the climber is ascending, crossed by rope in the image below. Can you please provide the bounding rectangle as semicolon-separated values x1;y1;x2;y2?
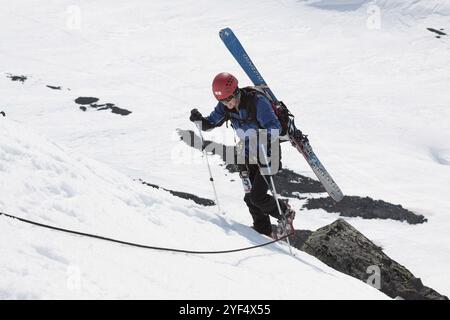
0;119;384;299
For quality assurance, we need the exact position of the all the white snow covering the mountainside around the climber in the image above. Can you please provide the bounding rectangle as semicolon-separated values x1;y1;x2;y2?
0;0;450;299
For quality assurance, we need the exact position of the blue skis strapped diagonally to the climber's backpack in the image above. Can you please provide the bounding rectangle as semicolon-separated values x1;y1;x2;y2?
219;28;344;201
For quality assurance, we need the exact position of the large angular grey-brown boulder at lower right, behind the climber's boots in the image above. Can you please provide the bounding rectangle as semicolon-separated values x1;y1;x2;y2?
295;219;448;300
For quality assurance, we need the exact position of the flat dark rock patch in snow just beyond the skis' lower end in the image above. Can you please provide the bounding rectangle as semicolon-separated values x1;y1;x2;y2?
304;196;427;224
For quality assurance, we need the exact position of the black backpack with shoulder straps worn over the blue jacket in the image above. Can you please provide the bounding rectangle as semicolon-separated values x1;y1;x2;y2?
225;86;293;136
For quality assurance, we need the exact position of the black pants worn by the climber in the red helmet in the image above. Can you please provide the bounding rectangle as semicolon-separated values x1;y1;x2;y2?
244;164;286;236
